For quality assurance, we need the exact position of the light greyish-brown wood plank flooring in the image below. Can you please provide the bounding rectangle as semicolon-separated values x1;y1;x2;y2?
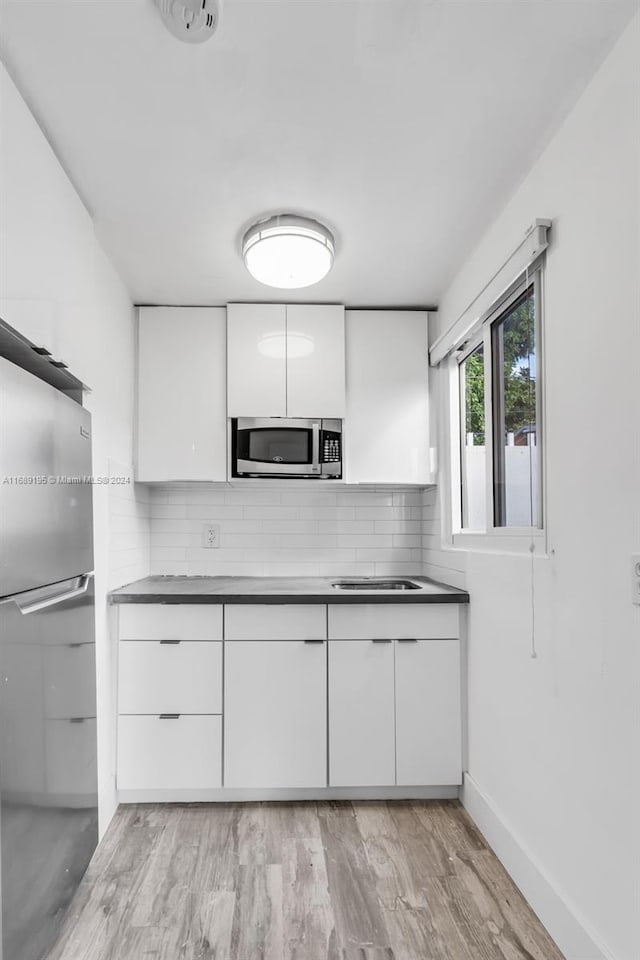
48;801;563;960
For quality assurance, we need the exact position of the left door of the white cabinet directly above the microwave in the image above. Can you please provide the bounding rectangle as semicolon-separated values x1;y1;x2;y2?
227;303;287;417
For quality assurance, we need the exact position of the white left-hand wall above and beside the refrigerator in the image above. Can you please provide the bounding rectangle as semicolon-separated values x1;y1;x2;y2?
0;66;148;829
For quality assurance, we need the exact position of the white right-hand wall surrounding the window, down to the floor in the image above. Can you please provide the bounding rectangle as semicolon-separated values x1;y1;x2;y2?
425;17;640;960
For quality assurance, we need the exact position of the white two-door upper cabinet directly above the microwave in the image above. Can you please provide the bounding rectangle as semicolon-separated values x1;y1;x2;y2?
227;303;345;419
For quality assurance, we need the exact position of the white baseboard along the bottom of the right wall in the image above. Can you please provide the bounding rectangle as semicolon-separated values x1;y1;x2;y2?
460;773;616;960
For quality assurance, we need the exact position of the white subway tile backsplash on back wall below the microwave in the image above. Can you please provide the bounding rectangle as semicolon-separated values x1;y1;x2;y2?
149;484;432;576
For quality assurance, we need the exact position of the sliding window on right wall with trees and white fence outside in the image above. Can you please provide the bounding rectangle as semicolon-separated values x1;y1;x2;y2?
457;270;541;533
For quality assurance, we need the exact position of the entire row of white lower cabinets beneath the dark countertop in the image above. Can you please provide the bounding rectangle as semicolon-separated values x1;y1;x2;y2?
116;603;462;800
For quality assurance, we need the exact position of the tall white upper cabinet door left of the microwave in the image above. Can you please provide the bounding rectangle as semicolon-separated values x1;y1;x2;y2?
136;307;227;482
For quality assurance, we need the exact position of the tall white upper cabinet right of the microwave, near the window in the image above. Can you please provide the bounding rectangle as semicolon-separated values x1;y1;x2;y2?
344;310;432;484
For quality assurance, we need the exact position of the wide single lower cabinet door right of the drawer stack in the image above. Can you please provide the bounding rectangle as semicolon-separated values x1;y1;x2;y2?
224;640;327;788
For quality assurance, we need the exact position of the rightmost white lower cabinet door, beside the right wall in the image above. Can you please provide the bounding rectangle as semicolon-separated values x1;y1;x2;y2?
395;640;462;786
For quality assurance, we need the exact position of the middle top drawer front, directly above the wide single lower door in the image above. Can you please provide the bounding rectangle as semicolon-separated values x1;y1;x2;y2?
224;603;327;640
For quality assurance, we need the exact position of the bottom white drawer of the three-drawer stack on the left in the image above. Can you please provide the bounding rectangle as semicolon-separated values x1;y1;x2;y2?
118;716;222;790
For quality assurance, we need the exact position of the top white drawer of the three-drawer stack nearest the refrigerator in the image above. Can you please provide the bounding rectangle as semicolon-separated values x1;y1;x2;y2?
119;603;222;640
